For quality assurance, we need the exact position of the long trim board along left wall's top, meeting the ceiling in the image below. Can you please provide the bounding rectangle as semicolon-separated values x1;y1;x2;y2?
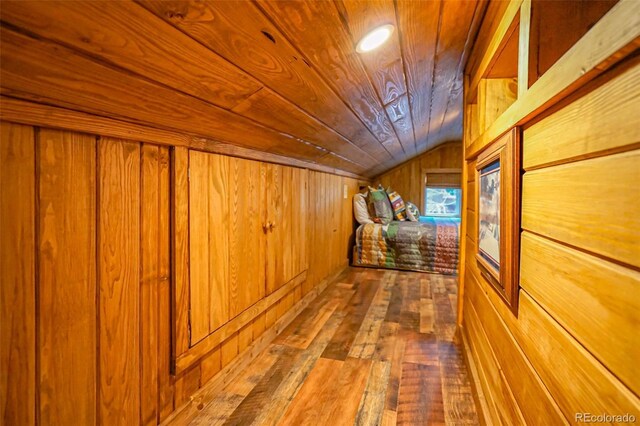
0;96;369;181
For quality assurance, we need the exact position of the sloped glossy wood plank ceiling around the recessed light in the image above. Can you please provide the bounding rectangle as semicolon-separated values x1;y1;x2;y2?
0;0;486;176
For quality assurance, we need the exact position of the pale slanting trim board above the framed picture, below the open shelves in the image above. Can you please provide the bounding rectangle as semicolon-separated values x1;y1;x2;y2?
465;0;640;160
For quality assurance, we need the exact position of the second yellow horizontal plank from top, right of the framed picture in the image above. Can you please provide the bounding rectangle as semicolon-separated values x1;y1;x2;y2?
522;150;640;267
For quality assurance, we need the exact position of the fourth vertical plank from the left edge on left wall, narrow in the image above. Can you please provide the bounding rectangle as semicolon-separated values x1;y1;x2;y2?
140;144;162;425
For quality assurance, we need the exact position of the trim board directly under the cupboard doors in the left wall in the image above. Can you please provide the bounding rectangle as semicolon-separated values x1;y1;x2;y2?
175;271;307;375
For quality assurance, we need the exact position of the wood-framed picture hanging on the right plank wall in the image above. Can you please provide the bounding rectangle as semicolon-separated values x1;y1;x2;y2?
476;128;520;313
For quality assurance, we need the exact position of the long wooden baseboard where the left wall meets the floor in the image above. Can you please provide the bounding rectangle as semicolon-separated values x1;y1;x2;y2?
162;265;347;425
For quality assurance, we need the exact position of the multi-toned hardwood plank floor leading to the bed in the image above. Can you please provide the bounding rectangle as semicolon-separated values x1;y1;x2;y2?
179;268;478;425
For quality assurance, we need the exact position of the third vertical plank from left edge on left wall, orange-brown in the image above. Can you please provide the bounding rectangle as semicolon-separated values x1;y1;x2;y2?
97;138;140;424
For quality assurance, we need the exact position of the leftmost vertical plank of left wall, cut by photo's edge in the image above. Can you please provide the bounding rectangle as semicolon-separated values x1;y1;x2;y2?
0;122;36;425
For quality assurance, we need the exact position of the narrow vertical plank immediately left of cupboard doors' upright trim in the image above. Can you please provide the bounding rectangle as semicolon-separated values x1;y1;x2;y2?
158;146;174;422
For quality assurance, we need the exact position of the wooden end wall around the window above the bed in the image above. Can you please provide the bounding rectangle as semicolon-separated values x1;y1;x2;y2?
373;142;462;210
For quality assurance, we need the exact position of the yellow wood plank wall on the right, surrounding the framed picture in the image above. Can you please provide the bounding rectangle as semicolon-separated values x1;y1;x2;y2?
462;1;640;425
